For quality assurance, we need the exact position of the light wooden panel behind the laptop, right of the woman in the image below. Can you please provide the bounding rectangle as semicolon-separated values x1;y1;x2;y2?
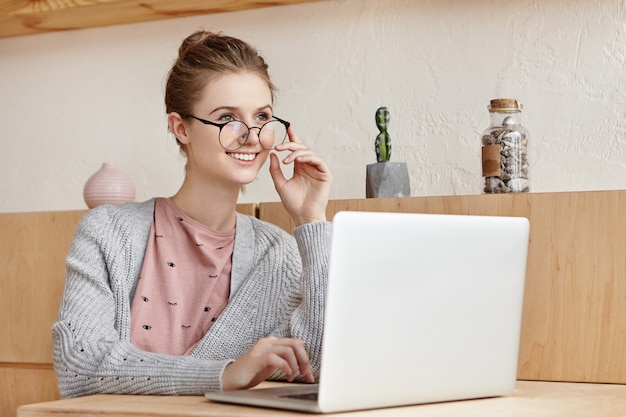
259;191;626;383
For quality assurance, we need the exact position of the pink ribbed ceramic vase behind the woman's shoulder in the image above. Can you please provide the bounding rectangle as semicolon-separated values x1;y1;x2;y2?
83;162;135;208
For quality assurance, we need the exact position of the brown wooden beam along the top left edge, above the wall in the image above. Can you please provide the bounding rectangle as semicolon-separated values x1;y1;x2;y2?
0;0;320;38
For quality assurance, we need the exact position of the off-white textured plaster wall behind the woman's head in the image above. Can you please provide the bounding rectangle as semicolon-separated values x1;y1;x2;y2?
0;0;626;212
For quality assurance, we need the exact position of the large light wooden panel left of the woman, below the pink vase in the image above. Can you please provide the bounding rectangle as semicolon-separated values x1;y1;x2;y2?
0;211;85;363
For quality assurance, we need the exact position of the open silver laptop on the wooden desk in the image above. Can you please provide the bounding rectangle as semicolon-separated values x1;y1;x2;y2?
206;212;529;413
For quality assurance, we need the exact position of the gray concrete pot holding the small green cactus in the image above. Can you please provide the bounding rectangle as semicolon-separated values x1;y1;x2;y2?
365;162;411;198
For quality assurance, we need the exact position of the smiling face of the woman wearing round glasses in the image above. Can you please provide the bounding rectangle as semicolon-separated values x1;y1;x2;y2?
182;72;272;187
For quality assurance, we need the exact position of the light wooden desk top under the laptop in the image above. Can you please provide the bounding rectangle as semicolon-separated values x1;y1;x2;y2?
17;381;626;417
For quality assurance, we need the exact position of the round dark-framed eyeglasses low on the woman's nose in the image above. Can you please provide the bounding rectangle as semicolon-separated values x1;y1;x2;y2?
185;114;290;151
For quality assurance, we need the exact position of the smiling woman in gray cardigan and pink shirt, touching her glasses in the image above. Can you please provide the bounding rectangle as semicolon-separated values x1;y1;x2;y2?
53;32;332;397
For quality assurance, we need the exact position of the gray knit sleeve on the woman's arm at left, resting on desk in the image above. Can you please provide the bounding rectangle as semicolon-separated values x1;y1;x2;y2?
52;207;229;397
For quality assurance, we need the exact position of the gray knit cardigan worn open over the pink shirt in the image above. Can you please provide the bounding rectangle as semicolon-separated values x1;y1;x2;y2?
52;200;331;397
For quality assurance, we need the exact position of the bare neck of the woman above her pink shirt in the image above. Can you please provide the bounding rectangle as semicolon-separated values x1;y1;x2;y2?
172;179;239;231
